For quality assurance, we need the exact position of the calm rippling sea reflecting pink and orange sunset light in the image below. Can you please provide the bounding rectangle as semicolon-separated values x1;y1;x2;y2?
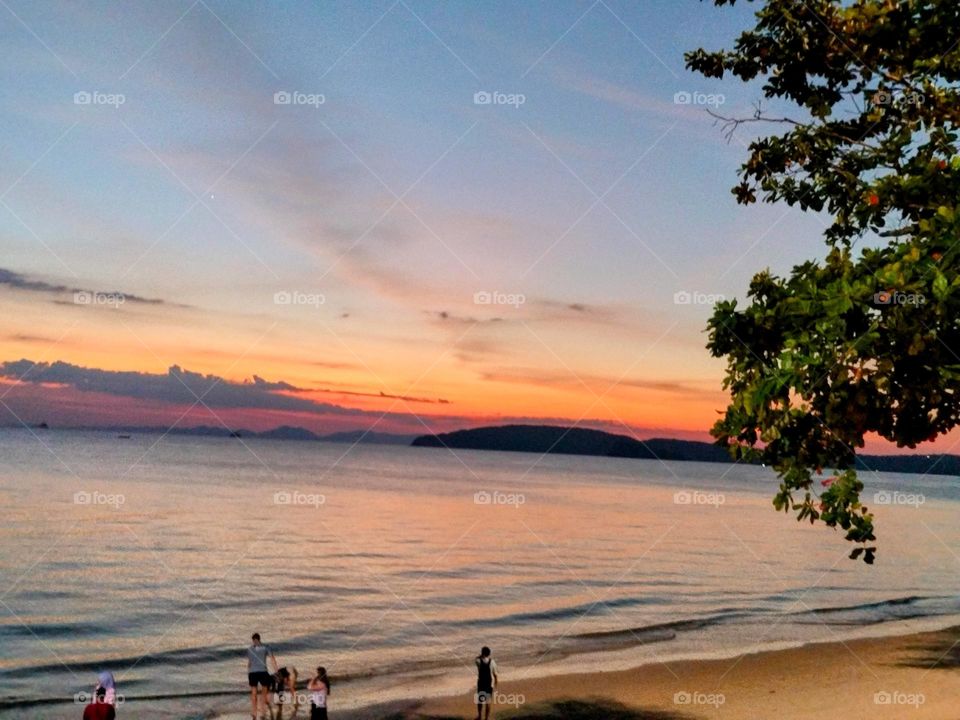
0;430;960;718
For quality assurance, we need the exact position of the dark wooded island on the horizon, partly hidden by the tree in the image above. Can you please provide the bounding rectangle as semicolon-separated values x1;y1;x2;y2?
412;425;960;475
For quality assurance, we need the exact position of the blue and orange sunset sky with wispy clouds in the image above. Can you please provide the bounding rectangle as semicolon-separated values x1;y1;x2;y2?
0;0;884;439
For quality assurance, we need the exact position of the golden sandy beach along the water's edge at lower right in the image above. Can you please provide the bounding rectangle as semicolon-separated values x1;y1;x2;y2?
390;628;960;720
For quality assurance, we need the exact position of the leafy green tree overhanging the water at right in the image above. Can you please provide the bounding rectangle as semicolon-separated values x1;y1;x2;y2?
685;0;960;563
